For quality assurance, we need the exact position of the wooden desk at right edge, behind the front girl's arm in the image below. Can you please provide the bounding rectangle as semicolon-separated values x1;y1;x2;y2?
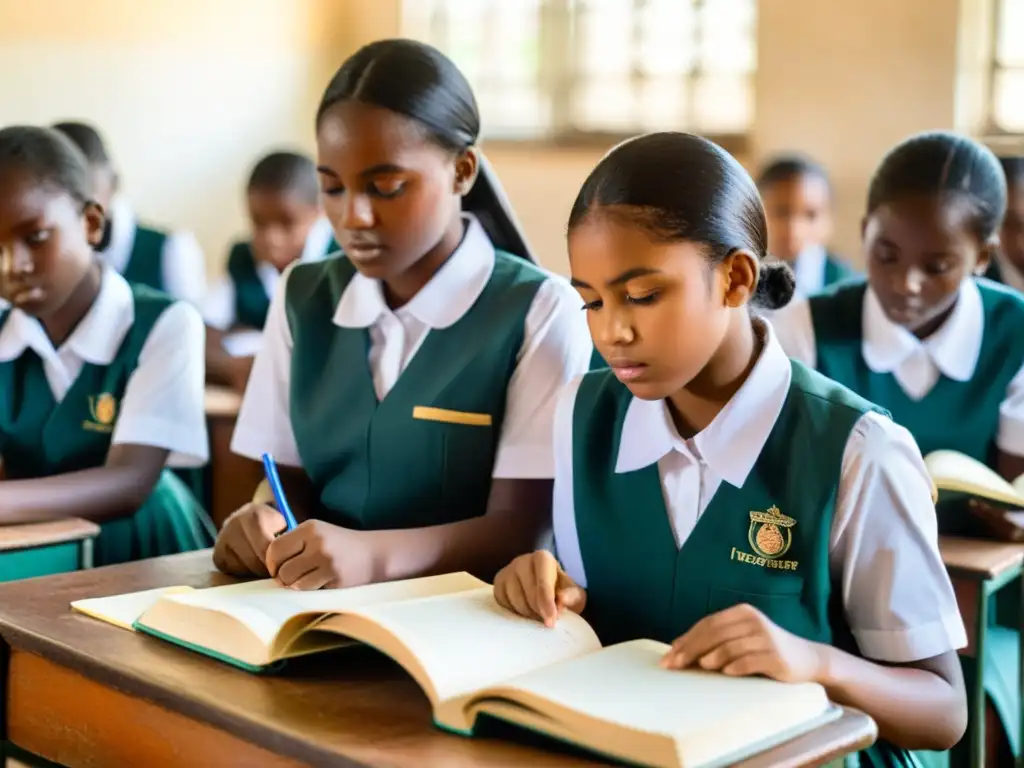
939;537;1024;765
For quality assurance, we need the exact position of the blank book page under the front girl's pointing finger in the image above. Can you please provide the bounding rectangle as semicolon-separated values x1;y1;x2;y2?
324;586;601;701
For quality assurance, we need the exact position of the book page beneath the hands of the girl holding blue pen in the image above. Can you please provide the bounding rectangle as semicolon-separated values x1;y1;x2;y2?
161;573;483;647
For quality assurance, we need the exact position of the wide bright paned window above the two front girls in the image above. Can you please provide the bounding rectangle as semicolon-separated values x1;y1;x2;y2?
403;0;757;139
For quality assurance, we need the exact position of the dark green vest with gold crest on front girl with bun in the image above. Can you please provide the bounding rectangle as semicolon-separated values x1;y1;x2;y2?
572;361;913;766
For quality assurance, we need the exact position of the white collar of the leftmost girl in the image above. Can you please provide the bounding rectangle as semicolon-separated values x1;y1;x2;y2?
0;266;135;366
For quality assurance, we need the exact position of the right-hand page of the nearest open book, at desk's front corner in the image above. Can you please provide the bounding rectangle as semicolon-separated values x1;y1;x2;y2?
479;640;829;765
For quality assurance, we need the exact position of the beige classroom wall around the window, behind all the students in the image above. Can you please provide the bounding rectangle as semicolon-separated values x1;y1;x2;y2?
0;0;988;271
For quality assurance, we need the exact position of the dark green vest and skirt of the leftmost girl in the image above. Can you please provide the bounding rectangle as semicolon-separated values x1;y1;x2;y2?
0;286;213;580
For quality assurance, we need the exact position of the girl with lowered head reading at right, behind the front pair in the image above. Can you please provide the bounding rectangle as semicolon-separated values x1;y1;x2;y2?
772;132;1024;765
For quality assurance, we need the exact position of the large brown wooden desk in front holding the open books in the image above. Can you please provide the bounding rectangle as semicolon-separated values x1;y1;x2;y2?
0;551;876;768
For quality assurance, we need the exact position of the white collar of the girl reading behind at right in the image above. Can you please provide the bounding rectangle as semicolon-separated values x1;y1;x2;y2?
861;278;985;381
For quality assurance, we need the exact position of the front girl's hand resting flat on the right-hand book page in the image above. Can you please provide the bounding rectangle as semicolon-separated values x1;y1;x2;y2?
662;603;824;683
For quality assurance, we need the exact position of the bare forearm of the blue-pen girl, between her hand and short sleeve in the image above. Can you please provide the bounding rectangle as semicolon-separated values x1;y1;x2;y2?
367;510;550;581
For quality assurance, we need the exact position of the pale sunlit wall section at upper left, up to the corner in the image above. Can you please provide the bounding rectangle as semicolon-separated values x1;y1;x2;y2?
0;0;340;271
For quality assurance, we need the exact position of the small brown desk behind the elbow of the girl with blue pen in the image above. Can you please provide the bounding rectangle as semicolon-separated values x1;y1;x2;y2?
206;386;263;529
